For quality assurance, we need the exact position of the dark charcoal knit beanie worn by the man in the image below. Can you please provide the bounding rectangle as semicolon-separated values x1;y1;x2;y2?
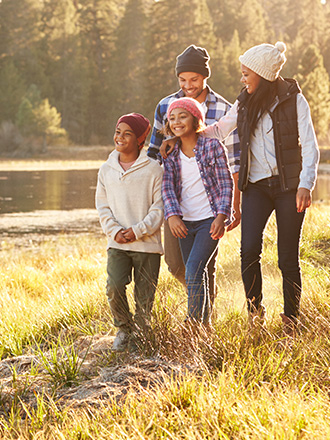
175;44;211;78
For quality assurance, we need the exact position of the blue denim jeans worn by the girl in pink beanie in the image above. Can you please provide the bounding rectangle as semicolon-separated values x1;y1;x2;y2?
180;217;219;324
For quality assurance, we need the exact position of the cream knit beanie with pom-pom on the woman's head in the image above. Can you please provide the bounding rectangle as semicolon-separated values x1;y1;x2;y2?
239;41;286;81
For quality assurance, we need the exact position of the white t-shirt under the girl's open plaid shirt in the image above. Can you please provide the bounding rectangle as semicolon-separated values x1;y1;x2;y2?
180;150;214;221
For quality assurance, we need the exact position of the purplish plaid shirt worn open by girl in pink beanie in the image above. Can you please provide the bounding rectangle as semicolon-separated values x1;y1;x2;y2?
162;136;233;225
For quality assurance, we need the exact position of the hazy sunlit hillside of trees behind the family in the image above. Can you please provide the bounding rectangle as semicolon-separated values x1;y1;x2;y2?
0;0;330;154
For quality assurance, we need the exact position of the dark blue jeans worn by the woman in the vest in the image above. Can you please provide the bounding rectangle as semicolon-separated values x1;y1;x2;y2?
241;177;305;318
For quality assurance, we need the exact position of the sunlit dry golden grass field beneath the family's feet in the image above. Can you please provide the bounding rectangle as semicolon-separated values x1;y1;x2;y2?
0;198;330;440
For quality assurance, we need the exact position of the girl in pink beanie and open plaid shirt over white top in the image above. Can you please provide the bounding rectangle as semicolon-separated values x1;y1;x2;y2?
162;98;233;325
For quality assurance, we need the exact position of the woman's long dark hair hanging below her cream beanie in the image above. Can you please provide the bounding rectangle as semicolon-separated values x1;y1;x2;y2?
247;77;277;134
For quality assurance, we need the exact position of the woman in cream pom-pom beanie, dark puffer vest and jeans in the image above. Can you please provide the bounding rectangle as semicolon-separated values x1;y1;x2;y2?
161;42;319;337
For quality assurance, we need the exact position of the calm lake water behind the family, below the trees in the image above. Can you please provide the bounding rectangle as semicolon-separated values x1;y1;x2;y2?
0;169;330;214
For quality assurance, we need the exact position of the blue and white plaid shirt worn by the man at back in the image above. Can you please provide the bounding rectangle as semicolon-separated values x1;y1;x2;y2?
148;86;240;174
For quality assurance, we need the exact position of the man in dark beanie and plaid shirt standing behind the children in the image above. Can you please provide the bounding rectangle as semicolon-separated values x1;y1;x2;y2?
148;45;241;305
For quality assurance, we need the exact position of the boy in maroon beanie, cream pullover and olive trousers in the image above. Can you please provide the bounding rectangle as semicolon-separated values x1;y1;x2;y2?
96;113;163;351
